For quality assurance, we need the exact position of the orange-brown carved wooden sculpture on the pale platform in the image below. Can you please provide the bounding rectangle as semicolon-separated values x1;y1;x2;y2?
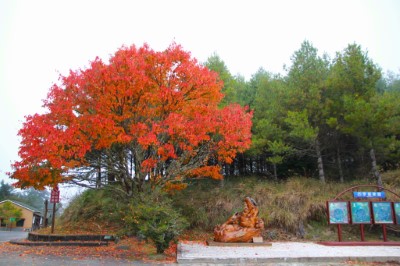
214;197;264;242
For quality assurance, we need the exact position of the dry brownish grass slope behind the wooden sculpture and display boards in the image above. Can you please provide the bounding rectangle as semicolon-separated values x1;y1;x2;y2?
174;171;400;241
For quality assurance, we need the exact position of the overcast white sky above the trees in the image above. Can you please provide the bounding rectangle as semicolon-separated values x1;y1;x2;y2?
0;0;400;200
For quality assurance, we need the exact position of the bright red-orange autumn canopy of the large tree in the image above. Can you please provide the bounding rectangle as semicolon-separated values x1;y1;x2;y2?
9;44;252;194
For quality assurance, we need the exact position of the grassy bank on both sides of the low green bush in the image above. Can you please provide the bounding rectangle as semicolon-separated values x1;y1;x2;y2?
49;170;400;244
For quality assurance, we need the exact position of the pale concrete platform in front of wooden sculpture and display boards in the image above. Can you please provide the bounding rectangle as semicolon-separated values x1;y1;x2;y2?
177;242;400;265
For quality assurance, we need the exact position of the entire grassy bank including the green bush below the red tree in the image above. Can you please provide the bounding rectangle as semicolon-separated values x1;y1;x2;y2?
60;171;400;249
